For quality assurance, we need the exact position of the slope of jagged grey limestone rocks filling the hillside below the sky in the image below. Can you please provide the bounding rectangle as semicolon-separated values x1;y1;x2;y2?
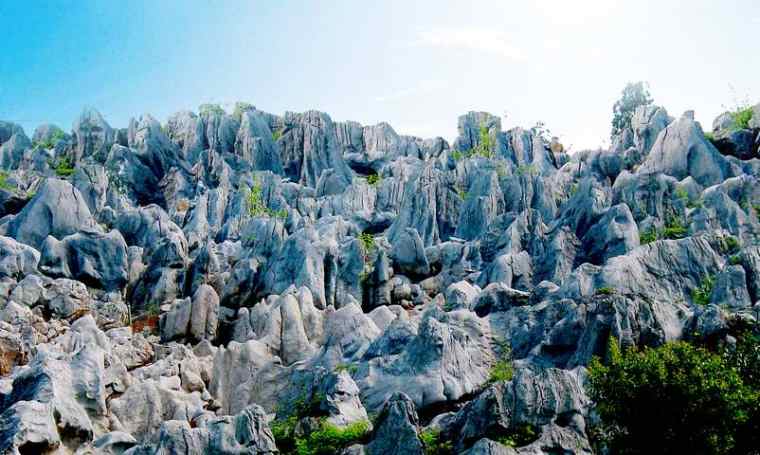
0;101;760;455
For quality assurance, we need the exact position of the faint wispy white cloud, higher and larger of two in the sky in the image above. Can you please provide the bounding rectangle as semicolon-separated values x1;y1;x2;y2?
415;27;525;60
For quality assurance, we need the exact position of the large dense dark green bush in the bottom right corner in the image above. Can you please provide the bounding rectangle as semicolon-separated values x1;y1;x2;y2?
589;338;758;455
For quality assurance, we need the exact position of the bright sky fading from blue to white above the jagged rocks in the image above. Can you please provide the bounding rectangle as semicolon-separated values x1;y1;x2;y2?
0;0;760;150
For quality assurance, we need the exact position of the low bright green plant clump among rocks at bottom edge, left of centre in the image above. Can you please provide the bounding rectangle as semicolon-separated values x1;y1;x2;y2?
294;419;370;455
